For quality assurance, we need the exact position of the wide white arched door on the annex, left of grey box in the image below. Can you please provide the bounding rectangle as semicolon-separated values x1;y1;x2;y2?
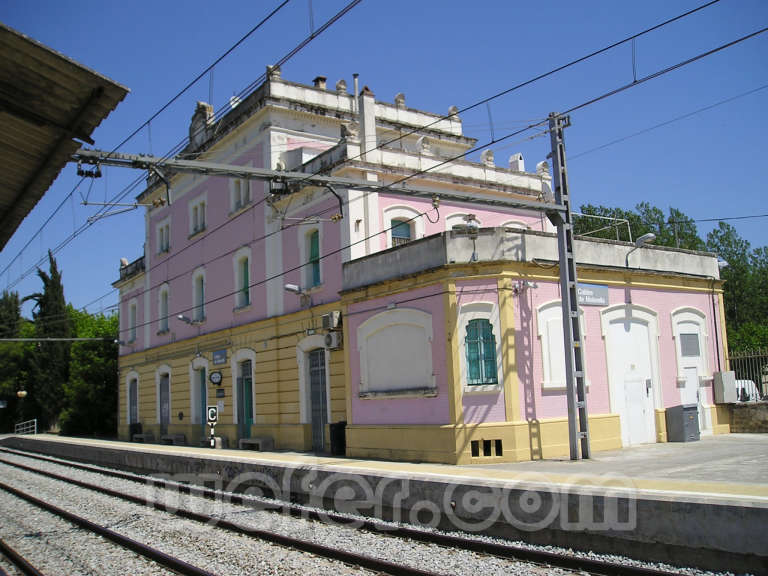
607;317;656;446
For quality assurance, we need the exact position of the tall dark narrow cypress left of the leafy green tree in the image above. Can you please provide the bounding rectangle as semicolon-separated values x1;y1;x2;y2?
24;250;72;430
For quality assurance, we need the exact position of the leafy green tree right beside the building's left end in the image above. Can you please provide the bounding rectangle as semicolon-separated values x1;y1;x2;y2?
60;306;118;437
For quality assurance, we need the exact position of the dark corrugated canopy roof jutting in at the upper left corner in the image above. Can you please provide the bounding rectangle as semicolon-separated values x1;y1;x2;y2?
0;23;128;250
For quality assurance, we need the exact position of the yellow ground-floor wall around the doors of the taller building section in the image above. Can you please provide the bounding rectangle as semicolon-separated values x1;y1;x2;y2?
118;302;346;451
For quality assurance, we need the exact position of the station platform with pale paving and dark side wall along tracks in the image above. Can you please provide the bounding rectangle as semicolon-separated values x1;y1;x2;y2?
0;434;768;573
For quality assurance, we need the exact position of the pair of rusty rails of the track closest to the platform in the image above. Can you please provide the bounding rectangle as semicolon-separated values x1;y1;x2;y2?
0;449;696;576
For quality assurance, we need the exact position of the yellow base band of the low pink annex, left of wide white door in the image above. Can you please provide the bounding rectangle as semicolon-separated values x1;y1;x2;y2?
347;414;621;464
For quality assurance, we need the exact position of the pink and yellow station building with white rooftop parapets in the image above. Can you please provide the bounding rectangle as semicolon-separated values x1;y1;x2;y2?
115;69;728;463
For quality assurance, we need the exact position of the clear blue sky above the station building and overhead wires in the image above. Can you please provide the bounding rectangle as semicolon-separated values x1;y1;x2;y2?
0;0;768;316
